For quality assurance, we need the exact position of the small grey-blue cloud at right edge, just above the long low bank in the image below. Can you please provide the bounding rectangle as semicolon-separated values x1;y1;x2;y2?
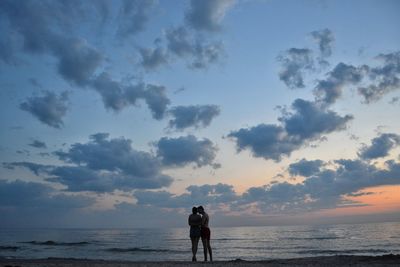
358;133;400;160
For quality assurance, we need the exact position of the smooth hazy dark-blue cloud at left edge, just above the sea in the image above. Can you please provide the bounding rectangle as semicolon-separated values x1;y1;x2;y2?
0;179;95;228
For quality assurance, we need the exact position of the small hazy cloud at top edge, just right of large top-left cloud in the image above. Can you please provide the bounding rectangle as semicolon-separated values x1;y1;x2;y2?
118;0;156;37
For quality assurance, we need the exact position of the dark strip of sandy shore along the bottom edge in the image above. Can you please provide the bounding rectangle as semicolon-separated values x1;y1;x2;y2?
0;254;400;267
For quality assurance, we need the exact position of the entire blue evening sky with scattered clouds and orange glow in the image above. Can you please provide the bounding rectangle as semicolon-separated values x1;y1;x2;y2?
0;0;400;227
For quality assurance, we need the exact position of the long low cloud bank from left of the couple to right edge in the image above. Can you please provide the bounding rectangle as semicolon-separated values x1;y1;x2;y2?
134;159;400;214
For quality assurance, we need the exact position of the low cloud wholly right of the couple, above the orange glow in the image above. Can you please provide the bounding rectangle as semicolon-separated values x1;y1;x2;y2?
238;159;400;214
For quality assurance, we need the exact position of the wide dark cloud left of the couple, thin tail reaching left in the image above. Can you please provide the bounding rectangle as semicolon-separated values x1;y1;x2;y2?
3;133;172;192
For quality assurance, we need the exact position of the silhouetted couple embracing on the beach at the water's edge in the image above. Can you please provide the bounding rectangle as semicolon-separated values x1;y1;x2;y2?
188;206;212;261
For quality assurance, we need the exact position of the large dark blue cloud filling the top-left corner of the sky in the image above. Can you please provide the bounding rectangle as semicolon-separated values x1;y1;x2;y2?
0;0;102;85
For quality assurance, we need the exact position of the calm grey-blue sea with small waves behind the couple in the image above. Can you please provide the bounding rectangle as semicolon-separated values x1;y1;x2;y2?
0;222;400;261
